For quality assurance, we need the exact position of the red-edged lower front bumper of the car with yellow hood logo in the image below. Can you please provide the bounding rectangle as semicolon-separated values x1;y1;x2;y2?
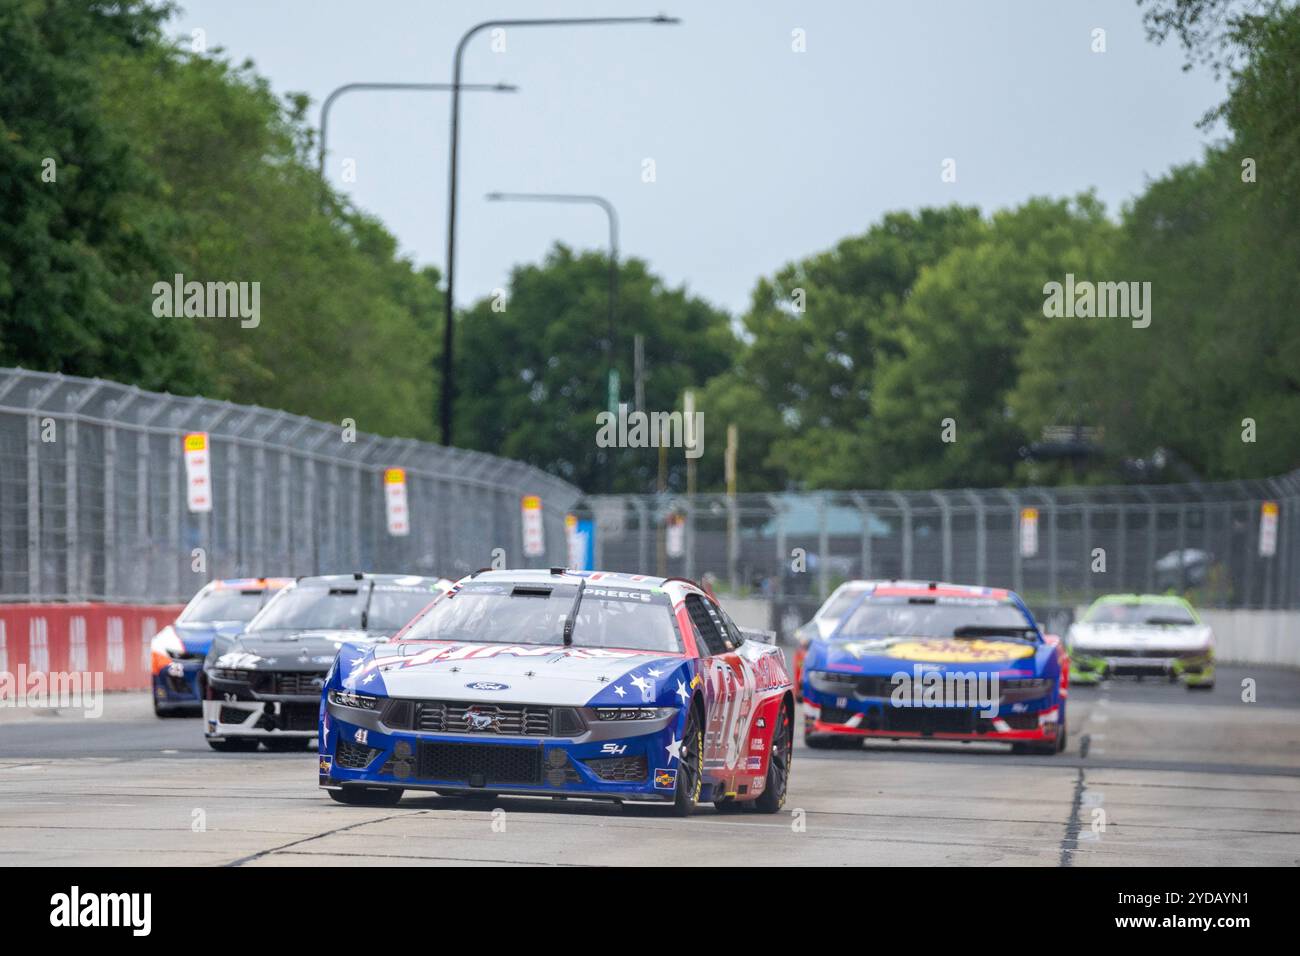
803;698;1063;743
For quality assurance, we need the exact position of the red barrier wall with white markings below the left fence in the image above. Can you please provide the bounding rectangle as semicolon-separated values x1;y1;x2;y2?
0;604;183;691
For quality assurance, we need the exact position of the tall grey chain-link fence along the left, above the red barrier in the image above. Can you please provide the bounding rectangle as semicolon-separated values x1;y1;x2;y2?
0;369;579;601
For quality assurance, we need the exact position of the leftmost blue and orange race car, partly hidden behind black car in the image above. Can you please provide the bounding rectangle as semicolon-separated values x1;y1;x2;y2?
150;578;293;717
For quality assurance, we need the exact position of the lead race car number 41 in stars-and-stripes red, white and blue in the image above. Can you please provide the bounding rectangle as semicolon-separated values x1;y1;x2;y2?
320;568;794;816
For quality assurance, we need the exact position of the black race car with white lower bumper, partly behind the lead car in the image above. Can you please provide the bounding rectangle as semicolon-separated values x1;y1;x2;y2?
203;574;451;750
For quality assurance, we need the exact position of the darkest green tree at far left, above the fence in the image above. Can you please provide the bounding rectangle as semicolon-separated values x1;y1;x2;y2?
0;0;207;390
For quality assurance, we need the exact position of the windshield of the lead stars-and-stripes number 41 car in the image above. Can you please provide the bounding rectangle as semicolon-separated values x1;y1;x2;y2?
404;583;681;653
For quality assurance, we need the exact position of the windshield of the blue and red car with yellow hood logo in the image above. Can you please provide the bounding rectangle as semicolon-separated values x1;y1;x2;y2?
837;597;1037;640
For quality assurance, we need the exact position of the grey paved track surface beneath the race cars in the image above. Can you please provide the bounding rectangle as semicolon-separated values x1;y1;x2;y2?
0;667;1300;866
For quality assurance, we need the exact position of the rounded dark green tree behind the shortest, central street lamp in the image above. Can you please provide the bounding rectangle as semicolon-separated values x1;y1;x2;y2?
455;245;736;492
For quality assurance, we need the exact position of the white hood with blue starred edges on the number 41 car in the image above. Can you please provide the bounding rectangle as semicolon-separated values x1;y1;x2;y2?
338;641;694;706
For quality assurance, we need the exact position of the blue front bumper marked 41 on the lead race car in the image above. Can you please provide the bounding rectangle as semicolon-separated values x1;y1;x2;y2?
319;701;683;803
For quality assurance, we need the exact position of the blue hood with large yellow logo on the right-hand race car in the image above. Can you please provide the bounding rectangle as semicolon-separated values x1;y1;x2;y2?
803;637;1050;676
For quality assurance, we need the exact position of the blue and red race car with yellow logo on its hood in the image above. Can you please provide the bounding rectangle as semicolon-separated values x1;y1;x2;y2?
803;581;1070;753
